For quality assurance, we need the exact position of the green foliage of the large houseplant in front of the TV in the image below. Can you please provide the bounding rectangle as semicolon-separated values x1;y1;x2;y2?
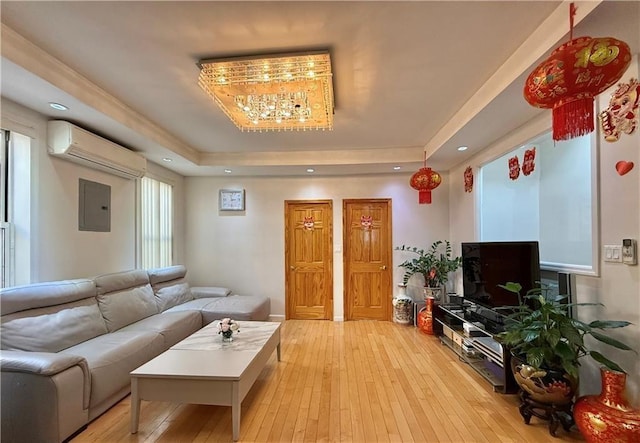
497;282;635;379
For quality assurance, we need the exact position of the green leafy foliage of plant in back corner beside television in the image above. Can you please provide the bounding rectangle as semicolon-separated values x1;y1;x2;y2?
395;240;462;298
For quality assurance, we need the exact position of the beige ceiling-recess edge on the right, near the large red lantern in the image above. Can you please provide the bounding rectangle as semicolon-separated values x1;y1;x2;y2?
424;0;604;158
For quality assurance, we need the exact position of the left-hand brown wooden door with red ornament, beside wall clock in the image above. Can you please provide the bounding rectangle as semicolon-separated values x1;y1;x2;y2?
284;200;333;320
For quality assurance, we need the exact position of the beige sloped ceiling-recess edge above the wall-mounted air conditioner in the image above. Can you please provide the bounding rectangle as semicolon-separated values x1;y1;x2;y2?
0;23;200;164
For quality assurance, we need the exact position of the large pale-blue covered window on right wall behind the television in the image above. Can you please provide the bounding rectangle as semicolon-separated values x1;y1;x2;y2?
479;133;598;275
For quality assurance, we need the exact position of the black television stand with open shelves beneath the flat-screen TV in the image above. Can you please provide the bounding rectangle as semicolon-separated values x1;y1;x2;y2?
433;304;518;394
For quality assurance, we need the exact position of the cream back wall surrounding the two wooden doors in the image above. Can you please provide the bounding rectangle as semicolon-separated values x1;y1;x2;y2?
185;171;449;320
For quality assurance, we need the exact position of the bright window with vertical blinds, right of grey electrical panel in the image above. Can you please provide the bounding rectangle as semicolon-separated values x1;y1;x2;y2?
140;177;173;269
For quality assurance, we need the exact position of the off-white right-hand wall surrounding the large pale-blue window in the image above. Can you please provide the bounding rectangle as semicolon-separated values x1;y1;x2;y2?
448;56;640;404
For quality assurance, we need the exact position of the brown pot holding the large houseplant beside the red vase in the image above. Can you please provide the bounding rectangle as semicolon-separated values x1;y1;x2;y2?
511;355;578;405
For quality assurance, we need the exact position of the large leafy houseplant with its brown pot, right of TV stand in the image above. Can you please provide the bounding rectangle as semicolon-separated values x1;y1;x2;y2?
496;282;633;404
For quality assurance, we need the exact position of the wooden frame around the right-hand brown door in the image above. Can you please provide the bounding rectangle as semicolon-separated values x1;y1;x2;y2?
342;198;393;321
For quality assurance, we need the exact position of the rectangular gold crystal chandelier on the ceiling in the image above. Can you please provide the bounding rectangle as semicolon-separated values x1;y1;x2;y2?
198;51;333;132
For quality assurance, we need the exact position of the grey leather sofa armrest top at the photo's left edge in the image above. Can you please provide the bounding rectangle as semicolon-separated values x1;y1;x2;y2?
0;350;91;408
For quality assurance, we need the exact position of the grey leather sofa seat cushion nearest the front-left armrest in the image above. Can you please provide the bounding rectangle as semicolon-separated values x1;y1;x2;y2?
62;331;164;408
